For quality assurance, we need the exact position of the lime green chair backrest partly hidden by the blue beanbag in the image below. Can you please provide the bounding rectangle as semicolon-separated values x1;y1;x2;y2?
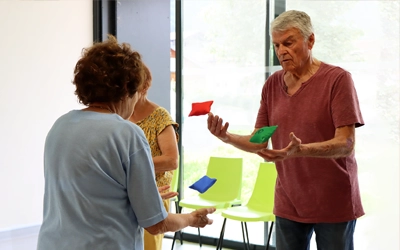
199;156;243;201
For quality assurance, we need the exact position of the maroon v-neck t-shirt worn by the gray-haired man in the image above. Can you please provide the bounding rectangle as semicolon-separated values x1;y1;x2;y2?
255;63;364;223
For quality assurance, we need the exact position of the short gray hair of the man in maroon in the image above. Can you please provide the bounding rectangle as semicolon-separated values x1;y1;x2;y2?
271;10;314;39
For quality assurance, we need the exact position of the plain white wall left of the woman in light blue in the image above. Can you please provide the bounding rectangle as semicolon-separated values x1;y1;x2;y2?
0;0;93;231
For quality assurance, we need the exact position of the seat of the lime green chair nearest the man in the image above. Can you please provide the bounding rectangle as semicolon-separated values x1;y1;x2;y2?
221;206;275;222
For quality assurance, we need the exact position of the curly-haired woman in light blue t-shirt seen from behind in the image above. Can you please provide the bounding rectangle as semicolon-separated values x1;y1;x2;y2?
37;36;215;250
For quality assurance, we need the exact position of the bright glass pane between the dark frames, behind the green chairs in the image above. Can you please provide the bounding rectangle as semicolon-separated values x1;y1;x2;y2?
182;0;266;245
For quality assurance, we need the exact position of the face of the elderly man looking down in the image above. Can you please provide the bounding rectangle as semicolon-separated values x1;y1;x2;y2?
272;28;314;72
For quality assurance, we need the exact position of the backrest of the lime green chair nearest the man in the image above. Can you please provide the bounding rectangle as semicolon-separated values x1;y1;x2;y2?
247;162;277;213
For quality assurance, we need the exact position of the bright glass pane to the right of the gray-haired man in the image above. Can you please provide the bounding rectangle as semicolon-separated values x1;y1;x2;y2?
286;0;400;250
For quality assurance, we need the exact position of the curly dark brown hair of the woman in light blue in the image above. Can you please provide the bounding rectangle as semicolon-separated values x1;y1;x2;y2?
73;35;145;105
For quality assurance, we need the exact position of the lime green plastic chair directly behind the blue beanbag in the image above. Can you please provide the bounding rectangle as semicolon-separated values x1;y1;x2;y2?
179;156;243;247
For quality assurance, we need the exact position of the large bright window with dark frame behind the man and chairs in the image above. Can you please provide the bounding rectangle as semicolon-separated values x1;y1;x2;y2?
173;0;400;250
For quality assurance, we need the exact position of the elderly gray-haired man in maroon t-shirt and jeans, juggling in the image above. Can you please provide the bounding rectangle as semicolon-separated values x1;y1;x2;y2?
207;10;364;250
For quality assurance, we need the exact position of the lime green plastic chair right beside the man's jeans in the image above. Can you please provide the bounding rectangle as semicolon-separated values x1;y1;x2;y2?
217;162;277;250
